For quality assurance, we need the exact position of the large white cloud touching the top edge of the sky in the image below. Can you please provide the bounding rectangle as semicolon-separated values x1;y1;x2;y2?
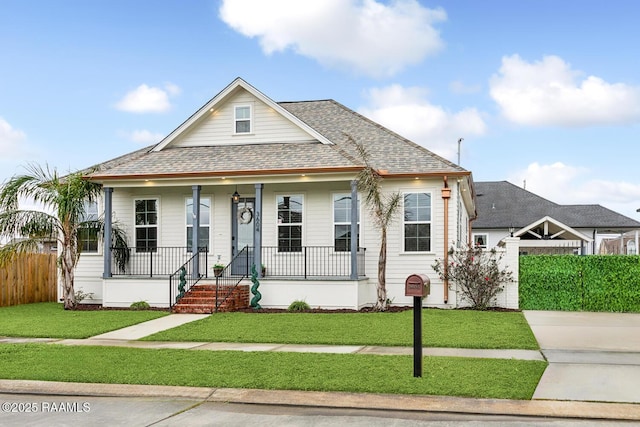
220;0;447;77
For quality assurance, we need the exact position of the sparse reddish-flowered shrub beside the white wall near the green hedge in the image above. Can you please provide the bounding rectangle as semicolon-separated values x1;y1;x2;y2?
433;246;513;310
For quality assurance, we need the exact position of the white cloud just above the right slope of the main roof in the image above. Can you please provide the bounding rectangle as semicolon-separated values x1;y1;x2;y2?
359;84;486;161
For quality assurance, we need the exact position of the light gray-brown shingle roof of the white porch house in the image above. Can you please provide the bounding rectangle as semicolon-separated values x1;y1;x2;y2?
89;100;469;178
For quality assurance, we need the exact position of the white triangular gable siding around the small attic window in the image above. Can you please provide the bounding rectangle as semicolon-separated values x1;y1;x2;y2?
171;90;315;147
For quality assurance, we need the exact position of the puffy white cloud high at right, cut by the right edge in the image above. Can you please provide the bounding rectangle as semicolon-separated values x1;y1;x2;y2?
490;55;640;126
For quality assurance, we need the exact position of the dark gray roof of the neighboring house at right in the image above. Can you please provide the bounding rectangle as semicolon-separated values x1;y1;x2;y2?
473;181;640;231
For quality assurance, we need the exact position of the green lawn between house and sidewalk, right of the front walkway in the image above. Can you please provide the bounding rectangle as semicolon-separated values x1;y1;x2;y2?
144;309;538;350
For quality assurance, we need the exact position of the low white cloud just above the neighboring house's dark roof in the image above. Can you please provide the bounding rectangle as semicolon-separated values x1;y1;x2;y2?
508;162;640;220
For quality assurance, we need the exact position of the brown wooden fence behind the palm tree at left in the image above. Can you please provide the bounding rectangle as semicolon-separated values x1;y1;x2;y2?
0;253;58;307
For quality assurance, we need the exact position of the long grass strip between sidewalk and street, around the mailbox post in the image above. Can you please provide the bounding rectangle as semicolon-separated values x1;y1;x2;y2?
0;344;546;399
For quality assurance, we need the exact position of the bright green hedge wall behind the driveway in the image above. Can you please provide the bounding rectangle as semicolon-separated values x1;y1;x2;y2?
519;255;640;312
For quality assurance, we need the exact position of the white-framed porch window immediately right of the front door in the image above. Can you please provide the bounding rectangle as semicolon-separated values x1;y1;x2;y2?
276;194;303;252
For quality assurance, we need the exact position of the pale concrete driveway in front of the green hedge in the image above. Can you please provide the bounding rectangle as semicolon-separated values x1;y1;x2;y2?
524;311;640;403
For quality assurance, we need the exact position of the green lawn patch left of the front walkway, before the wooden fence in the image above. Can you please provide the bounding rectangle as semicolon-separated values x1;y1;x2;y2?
0;302;168;338
